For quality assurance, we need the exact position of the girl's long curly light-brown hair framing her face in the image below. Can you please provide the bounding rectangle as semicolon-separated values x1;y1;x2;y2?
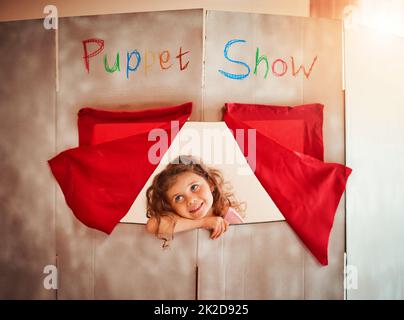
146;155;245;241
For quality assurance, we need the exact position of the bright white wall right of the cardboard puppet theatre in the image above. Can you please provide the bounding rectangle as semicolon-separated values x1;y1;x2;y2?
345;25;404;299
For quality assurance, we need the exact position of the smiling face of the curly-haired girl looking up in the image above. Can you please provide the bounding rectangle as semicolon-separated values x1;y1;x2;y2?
166;172;213;219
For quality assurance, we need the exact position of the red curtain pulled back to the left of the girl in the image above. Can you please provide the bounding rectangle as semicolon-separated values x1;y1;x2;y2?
49;103;192;234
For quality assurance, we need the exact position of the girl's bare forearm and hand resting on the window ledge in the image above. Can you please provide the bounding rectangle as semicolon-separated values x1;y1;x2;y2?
146;216;229;239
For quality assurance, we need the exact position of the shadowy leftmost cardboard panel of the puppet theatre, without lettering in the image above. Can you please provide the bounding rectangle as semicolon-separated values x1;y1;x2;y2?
0;20;56;299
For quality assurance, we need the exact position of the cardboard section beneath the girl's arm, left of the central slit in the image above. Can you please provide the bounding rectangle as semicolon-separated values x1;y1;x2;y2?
94;224;197;300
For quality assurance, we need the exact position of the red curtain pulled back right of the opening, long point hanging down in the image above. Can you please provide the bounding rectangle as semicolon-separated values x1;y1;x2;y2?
224;105;351;265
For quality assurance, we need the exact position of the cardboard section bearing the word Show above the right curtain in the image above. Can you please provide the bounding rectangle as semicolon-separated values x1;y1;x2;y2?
203;11;304;121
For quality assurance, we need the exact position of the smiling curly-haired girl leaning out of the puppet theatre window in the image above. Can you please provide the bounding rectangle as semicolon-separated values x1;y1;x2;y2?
146;156;244;247
